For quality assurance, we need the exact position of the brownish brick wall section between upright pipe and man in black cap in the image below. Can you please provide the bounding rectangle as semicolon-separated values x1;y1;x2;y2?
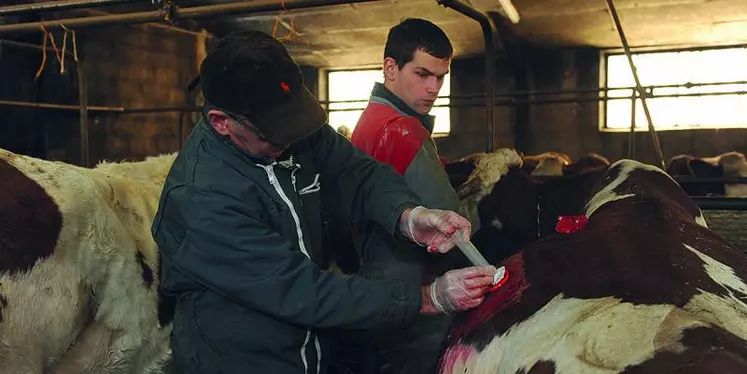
80;26;204;162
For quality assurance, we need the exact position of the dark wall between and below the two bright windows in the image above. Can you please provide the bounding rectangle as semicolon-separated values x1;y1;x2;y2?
437;46;747;163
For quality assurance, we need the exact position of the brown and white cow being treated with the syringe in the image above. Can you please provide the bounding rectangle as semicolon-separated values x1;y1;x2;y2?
440;150;747;374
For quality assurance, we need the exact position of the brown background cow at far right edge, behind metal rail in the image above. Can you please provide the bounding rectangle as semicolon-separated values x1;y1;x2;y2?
666;152;747;197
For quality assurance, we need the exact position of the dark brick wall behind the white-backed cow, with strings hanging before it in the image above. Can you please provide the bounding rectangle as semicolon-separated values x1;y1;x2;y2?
0;20;206;165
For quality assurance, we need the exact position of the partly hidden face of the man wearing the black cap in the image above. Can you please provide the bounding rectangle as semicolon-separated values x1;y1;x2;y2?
208;109;288;158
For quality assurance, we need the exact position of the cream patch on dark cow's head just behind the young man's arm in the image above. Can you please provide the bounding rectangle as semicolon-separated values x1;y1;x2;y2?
457;148;522;232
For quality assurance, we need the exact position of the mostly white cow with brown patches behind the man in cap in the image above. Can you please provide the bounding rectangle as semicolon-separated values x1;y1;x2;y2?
0;150;175;374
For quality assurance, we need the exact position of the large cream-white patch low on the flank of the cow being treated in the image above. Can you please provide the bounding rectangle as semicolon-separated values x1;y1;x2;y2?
453;295;705;374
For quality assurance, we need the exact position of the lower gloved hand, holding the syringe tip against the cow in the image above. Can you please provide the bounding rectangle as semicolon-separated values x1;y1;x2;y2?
420;266;496;314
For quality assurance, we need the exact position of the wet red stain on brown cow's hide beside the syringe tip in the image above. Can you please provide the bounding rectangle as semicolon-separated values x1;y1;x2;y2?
451;253;529;339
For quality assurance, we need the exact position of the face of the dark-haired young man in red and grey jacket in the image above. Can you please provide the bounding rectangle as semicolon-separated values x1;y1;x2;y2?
384;50;451;114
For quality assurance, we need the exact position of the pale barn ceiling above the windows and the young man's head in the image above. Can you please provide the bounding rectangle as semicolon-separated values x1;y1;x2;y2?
0;0;747;67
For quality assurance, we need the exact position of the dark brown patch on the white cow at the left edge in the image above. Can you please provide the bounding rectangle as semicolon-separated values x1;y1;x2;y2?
0;160;62;274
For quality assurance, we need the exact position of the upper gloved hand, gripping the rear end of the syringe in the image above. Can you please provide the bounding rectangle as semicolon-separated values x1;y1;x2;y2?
400;206;472;253
